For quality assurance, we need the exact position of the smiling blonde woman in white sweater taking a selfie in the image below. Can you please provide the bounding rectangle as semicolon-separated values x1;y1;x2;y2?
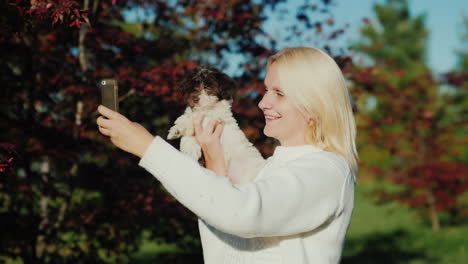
98;48;357;263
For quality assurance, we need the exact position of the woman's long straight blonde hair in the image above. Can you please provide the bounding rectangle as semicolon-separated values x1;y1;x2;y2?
267;47;358;178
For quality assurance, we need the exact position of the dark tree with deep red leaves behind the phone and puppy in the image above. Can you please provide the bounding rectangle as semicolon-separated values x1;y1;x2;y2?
0;0;338;263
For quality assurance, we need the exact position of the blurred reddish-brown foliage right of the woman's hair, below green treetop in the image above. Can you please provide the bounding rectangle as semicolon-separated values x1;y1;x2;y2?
347;63;468;220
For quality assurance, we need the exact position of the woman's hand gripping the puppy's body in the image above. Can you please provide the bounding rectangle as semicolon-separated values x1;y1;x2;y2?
193;115;227;176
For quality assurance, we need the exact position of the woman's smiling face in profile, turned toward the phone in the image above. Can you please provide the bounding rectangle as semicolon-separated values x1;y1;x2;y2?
258;63;309;146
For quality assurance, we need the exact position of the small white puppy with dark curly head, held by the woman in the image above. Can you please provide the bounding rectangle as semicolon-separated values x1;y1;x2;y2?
167;67;265;186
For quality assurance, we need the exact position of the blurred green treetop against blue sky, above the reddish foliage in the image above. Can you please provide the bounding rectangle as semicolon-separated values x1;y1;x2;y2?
352;0;428;83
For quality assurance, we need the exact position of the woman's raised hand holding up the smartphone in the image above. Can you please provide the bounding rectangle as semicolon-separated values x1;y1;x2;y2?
97;105;154;158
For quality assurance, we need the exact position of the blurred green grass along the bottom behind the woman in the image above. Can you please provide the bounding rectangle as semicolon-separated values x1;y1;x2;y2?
132;182;468;264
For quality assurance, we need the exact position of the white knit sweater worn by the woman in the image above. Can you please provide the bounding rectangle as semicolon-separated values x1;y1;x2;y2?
139;137;355;264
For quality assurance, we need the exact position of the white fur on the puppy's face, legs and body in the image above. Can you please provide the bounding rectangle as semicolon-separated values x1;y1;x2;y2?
167;90;265;186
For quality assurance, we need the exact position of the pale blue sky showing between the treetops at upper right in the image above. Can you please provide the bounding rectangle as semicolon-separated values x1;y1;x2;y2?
265;0;468;73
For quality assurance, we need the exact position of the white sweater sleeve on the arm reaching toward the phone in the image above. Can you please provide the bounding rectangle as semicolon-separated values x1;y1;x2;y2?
139;137;347;238
